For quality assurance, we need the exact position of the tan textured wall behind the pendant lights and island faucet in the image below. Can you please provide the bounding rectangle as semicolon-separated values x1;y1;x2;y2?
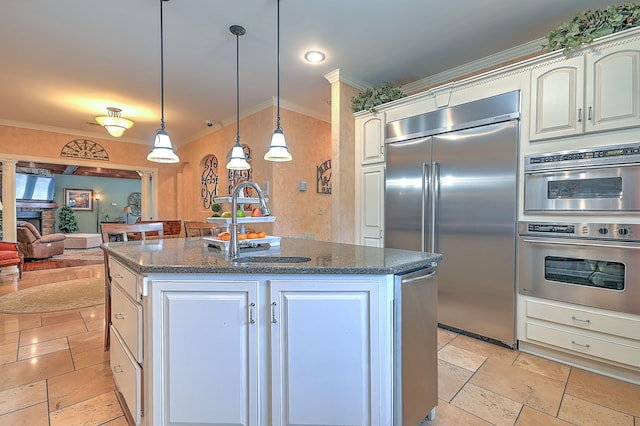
178;108;331;241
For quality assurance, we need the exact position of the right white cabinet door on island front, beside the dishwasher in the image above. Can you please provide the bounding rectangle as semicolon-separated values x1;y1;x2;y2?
270;280;382;426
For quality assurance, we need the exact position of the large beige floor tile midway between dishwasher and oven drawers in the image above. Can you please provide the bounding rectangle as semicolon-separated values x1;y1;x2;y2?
469;359;565;416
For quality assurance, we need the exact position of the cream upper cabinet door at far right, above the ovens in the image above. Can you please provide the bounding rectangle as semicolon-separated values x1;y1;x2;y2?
586;42;640;131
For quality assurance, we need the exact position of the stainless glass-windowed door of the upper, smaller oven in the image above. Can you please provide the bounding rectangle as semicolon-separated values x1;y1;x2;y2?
524;165;640;213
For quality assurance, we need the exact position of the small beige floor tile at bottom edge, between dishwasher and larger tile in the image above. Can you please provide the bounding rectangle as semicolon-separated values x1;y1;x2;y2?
451;383;522;425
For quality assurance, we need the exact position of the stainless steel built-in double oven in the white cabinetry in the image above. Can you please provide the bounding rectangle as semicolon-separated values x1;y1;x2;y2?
518;143;640;314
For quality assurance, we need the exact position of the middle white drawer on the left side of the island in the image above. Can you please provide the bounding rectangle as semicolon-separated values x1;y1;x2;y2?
111;285;142;363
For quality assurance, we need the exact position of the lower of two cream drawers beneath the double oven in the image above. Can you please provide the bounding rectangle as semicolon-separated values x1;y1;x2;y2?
527;322;640;367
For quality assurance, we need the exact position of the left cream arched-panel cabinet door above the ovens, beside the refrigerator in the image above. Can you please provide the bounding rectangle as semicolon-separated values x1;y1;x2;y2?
529;56;584;140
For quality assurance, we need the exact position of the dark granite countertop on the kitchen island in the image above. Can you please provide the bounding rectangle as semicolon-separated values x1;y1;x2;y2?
101;237;442;275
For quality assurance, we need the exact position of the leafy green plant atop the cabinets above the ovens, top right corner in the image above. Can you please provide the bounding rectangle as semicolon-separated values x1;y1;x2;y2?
546;3;640;54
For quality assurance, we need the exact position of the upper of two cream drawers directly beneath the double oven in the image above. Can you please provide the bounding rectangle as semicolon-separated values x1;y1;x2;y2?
527;300;640;341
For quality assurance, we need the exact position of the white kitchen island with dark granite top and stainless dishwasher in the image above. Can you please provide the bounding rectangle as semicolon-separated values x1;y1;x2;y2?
102;238;441;425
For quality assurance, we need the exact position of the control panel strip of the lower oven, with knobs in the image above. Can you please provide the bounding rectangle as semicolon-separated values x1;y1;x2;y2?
518;222;640;241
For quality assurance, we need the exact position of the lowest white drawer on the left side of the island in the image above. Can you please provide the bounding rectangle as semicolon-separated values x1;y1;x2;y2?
110;327;142;425
